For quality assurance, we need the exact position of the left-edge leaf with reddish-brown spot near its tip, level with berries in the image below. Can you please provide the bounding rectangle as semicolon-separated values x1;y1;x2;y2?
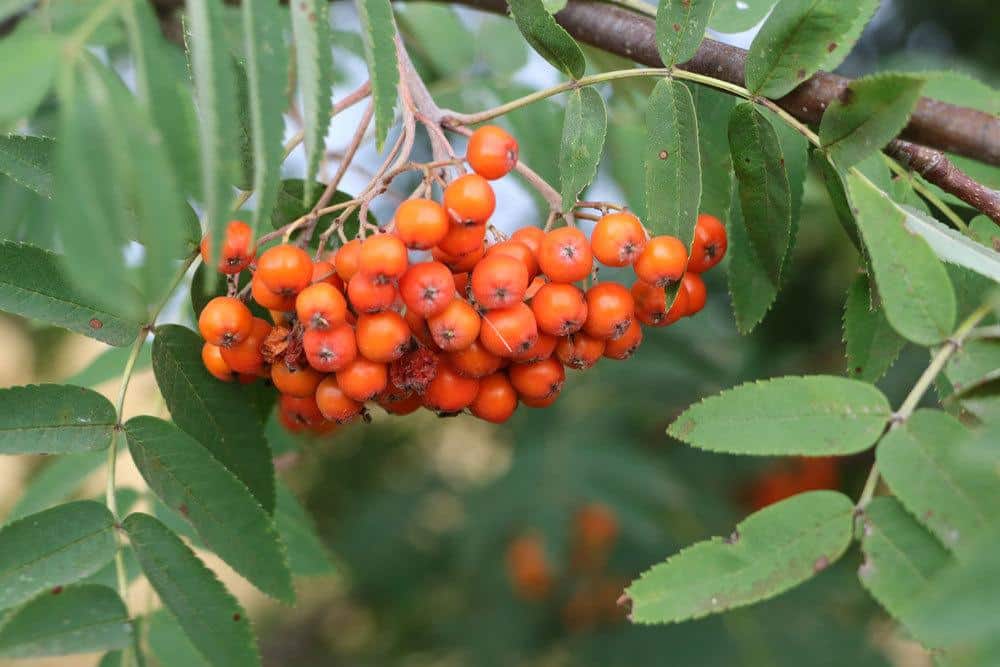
0;241;142;346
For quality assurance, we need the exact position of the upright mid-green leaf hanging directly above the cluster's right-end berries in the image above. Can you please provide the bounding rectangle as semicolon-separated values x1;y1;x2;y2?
644;79;701;247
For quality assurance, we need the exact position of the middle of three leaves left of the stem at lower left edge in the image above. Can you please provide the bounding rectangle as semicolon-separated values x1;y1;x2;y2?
0;500;116;609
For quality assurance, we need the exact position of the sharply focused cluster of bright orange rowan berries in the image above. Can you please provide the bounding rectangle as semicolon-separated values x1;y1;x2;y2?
198;126;726;432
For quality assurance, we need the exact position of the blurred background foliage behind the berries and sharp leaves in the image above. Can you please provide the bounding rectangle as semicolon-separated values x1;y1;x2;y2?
0;0;1000;667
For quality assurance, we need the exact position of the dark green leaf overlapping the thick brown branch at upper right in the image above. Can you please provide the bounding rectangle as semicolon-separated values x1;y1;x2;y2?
819;73;925;168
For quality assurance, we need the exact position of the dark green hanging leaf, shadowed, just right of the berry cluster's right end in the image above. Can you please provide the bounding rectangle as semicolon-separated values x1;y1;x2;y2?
729;102;792;285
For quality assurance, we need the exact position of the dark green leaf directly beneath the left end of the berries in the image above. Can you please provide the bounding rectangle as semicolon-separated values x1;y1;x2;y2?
153;325;274;513
